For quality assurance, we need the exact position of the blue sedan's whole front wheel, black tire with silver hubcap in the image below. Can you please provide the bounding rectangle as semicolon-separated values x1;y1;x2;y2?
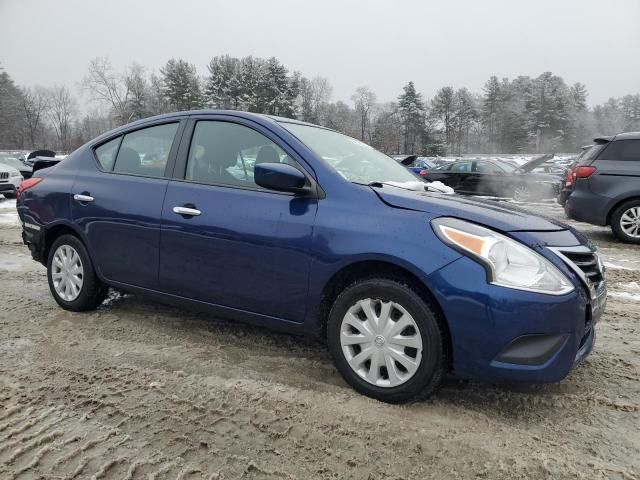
327;278;444;403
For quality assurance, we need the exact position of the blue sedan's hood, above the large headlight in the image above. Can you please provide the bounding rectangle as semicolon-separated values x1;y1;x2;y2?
371;185;569;232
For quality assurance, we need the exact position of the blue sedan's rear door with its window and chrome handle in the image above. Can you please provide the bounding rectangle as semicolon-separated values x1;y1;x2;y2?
71;121;181;289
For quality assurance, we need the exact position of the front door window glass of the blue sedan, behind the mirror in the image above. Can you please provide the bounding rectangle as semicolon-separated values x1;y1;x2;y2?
185;121;297;188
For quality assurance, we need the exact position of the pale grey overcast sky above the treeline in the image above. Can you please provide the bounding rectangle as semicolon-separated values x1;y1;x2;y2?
0;0;640;105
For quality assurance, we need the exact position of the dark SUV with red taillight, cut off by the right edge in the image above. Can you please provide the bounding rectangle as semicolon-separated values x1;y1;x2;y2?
565;132;640;244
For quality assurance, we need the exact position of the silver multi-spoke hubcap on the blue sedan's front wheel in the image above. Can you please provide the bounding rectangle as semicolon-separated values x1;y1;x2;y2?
340;298;422;387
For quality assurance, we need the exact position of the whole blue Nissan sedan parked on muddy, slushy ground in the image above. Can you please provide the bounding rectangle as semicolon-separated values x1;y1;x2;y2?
17;111;606;402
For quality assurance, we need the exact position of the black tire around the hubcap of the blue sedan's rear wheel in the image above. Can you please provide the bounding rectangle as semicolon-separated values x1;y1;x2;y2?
47;235;108;312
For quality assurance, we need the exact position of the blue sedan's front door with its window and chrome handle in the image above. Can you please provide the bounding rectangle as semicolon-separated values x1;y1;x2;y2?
160;116;318;322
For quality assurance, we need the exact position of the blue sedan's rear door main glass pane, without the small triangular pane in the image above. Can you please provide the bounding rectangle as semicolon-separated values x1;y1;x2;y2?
113;123;178;177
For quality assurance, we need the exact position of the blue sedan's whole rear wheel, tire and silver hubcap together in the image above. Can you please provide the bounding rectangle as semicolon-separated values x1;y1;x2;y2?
47;235;107;312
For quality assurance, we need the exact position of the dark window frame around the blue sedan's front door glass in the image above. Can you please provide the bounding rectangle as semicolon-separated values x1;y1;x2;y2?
169;114;324;199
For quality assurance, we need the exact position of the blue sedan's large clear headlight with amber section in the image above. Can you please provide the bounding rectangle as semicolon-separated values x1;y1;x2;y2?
431;218;574;295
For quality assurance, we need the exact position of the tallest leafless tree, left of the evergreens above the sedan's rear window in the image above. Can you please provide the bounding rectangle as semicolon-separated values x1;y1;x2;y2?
80;57;131;124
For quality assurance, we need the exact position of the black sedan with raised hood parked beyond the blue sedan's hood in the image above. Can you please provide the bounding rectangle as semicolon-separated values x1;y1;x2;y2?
424;158;562;201
